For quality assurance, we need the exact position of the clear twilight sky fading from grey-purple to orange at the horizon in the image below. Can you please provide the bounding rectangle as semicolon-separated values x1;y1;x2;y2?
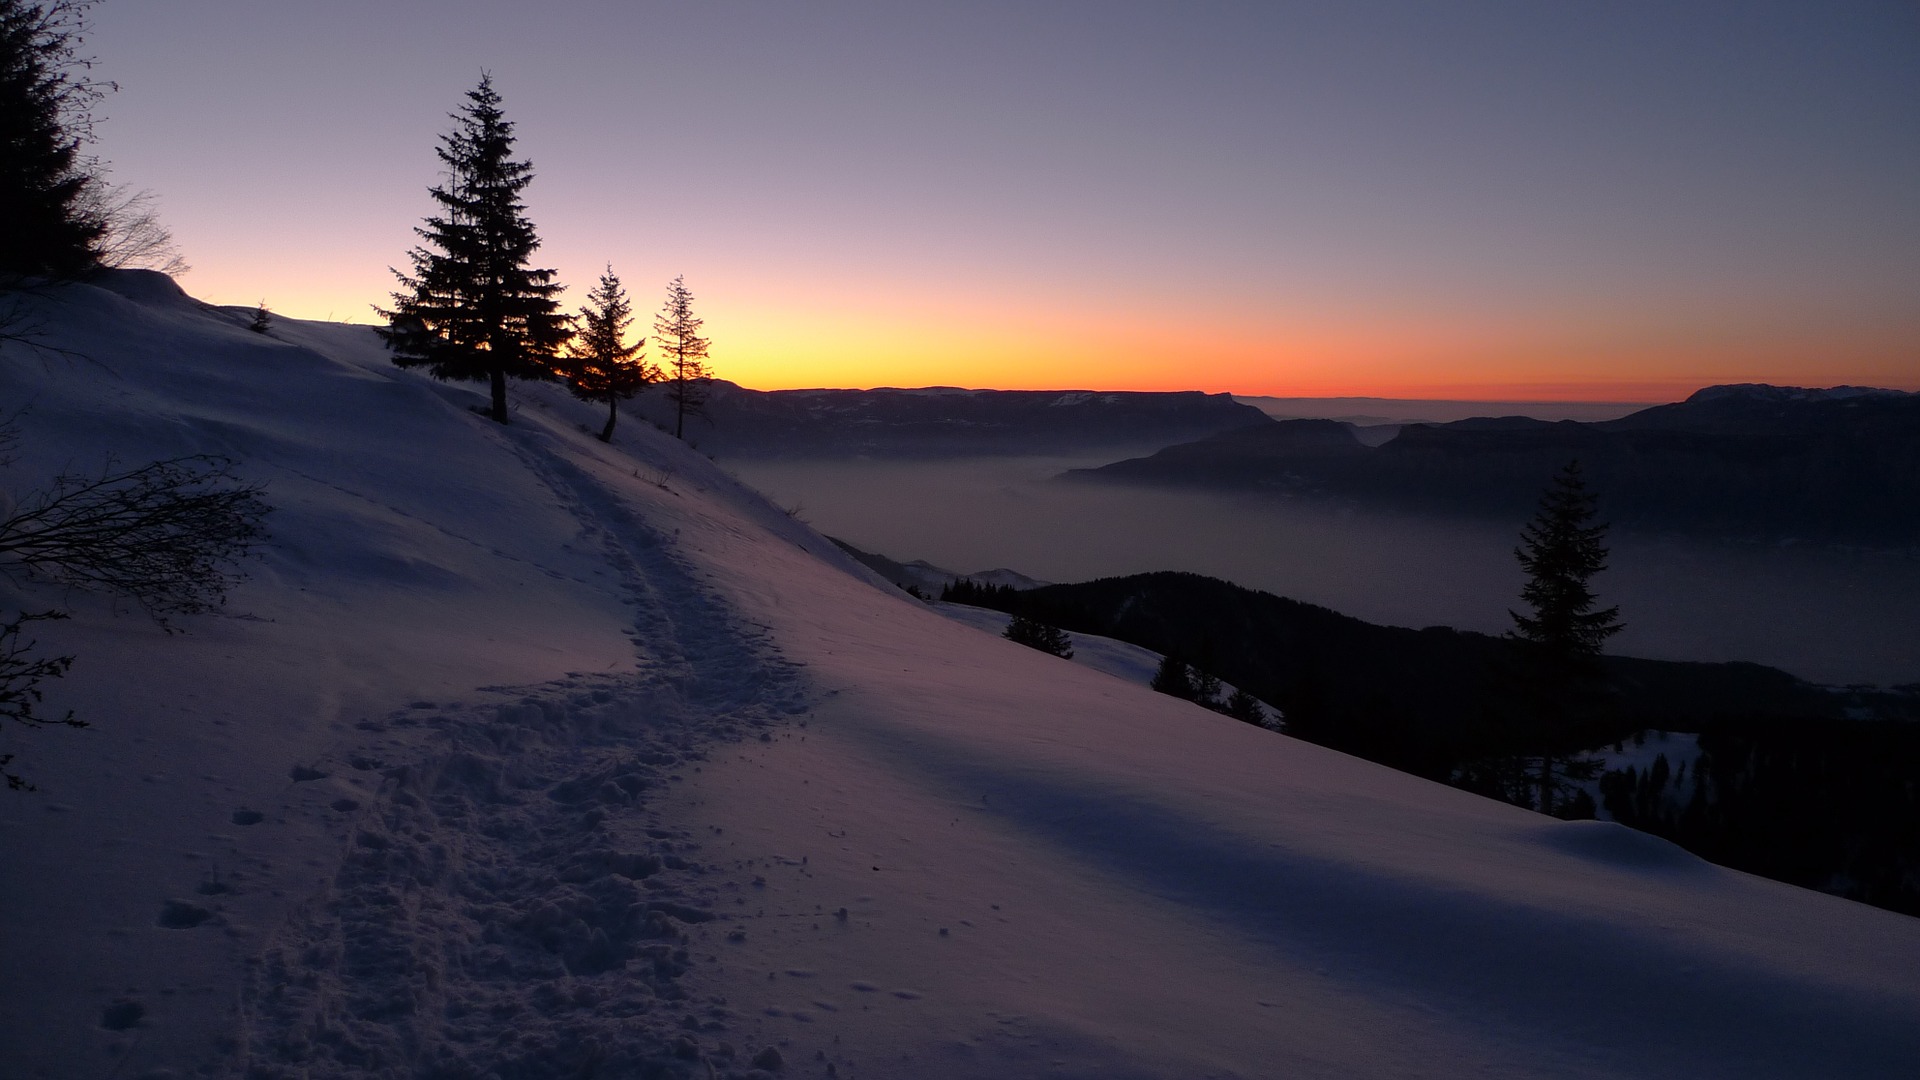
74;0;1920;402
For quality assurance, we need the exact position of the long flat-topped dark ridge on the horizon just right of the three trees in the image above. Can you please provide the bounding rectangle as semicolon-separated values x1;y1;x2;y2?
626;380;1265;457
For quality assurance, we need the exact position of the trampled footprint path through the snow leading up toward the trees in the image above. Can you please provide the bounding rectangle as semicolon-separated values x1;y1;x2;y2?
230;436;806;1080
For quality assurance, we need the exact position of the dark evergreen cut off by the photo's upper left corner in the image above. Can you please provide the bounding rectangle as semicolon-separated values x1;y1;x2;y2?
0;0;113;276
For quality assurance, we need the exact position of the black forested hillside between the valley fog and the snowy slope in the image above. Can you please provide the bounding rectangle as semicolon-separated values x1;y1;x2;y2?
948;573;1920;911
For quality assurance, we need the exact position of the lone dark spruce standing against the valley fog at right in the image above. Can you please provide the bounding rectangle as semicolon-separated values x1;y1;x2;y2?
1507;461;1622;813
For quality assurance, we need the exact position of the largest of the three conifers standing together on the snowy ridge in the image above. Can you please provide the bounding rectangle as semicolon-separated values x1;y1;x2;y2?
376;75;570;423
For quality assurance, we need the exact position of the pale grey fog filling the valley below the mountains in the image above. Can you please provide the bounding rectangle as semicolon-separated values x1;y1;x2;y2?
726;457;1920;684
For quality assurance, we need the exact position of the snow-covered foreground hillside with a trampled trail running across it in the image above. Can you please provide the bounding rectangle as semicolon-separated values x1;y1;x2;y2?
0;275;1920;1078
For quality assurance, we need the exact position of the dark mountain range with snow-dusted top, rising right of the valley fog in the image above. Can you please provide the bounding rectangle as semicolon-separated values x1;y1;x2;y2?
1064;384;1920;544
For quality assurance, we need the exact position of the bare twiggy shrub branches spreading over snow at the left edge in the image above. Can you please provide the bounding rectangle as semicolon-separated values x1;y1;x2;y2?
0;455;267;625
